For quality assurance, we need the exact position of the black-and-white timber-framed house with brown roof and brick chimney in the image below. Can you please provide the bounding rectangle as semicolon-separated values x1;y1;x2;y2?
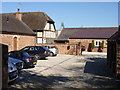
4;9;56;44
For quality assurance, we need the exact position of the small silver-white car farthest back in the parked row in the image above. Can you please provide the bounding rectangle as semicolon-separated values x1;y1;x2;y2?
42;45;58;56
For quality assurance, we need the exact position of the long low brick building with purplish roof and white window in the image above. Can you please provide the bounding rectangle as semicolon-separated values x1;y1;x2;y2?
55;27;118;52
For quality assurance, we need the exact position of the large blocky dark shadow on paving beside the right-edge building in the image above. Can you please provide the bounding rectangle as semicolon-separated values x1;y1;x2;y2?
84;57;113;77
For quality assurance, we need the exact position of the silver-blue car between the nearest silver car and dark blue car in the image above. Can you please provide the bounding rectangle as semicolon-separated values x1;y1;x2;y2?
8;57;23;72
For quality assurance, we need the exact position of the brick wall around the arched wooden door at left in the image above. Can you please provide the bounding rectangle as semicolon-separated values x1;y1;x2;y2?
0;34;35;51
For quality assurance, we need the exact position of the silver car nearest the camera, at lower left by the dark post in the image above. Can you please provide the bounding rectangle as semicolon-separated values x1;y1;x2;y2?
8;62;18;83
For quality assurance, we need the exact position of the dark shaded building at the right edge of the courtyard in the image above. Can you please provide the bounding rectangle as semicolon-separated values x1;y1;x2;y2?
107;27;120;78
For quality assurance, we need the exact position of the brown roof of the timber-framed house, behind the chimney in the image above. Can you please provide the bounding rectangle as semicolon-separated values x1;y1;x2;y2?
4;12;54;30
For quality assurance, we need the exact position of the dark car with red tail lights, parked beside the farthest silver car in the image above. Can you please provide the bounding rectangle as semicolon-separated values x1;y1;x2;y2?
20;46;50;60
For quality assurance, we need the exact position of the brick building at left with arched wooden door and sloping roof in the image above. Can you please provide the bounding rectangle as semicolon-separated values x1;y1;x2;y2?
0;14;35;51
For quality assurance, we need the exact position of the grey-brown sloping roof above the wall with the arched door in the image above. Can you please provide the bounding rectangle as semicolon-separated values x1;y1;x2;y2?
0;14;35;35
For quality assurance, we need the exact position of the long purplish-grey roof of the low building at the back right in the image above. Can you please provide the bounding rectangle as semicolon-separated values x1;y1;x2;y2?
57;27;118;40
